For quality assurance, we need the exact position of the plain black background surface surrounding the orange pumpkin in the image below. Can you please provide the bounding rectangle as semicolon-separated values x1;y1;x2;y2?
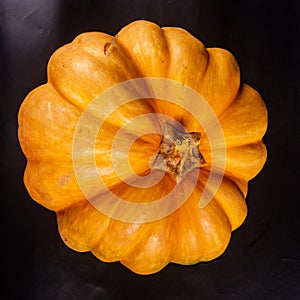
0;0;300;300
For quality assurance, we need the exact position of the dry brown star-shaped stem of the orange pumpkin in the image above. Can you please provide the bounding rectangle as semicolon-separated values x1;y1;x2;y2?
152;123;204;183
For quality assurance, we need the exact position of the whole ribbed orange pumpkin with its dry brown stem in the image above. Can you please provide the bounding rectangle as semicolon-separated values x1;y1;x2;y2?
18;20;267;274
